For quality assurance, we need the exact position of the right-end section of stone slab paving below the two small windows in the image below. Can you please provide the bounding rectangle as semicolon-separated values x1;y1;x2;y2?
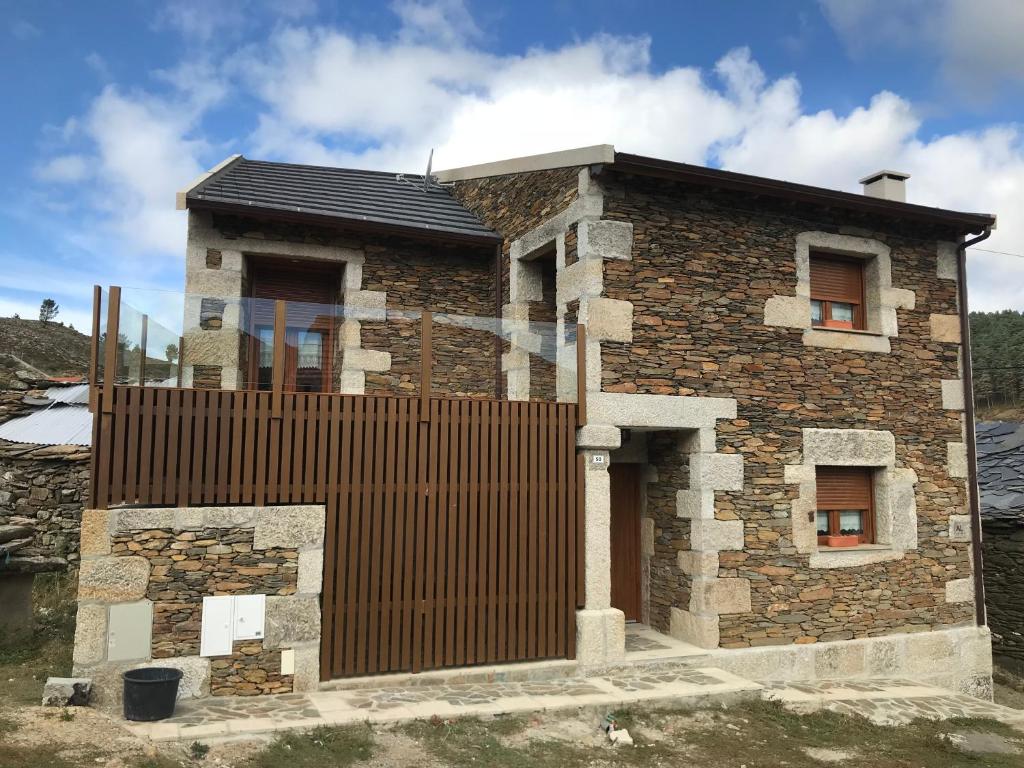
764;680;1024;726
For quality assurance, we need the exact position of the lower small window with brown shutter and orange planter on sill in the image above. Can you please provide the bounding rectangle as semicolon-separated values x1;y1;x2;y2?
816;467;874;547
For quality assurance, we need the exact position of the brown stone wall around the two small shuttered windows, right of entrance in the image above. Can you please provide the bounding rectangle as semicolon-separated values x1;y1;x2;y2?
591;174;973;647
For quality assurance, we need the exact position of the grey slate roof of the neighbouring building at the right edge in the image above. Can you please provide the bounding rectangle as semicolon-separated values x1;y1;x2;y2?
975;421;1024;522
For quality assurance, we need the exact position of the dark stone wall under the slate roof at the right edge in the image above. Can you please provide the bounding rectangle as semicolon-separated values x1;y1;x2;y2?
982;518;1024;673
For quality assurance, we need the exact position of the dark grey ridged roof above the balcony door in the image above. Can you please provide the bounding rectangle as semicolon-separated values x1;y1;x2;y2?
186;158;501;241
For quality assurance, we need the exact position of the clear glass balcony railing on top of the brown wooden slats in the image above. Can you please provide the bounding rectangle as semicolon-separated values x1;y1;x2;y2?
96;289;578;402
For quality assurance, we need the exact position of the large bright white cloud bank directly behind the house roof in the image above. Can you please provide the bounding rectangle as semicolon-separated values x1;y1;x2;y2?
29;0;1024;308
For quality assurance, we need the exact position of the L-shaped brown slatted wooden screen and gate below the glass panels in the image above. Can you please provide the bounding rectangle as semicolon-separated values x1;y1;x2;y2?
92;386;583;679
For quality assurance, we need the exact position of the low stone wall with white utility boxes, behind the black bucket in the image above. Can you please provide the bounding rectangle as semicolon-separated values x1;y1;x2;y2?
74;505;325;705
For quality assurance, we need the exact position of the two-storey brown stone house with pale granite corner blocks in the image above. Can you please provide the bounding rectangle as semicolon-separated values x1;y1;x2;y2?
76;145;994;695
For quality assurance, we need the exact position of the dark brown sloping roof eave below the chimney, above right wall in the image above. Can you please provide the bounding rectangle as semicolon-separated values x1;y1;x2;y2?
605;153;995;234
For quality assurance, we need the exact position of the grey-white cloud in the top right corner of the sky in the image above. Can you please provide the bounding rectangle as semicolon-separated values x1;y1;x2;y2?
819;0;1024;96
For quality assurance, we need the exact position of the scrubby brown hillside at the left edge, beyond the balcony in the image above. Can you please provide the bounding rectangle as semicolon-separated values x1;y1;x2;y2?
0;317;89;384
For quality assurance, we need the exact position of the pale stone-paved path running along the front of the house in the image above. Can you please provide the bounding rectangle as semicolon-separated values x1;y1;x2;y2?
128;667;1024;741
